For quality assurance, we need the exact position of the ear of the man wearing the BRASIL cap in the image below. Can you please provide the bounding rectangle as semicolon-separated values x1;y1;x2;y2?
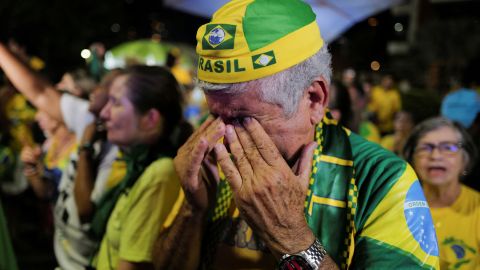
306;76;329;125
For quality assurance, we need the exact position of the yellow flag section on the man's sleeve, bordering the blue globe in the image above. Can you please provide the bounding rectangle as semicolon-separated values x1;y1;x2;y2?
360;166;439;269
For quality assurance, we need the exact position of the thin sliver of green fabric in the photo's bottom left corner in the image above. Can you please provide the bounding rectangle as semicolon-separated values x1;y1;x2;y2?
0;199;18;270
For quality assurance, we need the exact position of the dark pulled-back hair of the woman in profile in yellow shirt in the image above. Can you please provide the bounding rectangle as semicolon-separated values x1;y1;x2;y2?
122;66;193;154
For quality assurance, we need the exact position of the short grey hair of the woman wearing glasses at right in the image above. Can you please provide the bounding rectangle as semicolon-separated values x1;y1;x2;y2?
402;117;477;176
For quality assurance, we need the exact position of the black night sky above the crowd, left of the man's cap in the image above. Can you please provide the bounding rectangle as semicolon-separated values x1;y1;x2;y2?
0;0;207;79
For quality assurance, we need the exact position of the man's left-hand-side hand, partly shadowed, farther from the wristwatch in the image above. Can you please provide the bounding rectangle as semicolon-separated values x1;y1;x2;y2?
174;116;225;213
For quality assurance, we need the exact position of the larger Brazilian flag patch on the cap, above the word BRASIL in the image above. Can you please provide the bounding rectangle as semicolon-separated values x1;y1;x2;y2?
202;24;236;50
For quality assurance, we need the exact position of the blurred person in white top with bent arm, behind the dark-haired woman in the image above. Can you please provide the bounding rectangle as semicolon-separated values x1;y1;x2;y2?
54;70;126;269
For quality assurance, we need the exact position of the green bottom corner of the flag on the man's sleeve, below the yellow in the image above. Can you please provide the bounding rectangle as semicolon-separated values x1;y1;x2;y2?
350;237;431;270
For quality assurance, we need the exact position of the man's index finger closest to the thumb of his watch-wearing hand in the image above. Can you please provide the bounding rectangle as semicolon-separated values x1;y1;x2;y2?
243;117;283;166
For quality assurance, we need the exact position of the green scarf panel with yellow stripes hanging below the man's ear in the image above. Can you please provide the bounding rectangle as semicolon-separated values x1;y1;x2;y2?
305;116;353;263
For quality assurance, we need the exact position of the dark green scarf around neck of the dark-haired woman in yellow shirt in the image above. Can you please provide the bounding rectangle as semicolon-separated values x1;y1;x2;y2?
91;145;163;240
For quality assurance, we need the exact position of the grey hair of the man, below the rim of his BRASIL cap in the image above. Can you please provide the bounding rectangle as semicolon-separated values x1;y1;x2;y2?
197;44;332;117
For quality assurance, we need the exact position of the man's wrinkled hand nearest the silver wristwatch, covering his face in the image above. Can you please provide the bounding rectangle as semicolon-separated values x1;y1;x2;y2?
215;118;316;256
